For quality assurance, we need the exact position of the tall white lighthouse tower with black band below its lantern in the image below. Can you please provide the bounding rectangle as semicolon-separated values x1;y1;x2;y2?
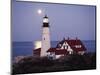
40;15;50;57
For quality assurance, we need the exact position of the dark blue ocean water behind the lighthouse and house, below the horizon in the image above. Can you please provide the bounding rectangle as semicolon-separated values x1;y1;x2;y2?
11;40;96;57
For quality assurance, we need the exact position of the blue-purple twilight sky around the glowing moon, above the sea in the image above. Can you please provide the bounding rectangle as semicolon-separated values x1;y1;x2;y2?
12;1;96;41
